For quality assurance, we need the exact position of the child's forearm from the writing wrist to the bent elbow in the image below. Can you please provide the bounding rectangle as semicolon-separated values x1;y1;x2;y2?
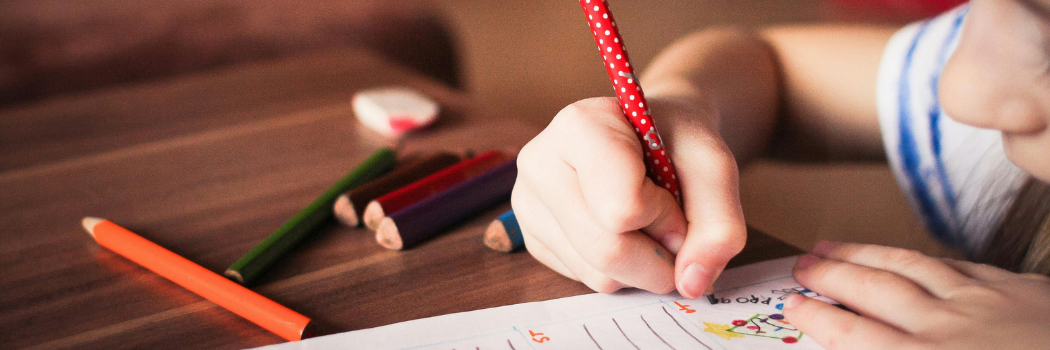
641;29;779;165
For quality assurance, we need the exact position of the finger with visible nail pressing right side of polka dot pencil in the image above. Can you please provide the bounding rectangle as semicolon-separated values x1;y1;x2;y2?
671;130;748;298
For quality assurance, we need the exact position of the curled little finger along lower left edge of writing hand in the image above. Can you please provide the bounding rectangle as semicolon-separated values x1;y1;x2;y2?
511;182;625;293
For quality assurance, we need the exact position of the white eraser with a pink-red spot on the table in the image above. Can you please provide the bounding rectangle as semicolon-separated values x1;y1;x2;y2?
351;87;440;136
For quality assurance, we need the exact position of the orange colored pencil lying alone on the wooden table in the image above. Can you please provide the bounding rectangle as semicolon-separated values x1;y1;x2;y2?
83;217;313;342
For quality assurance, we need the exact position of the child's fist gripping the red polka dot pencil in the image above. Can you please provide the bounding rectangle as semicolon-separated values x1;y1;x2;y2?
511;94;747;297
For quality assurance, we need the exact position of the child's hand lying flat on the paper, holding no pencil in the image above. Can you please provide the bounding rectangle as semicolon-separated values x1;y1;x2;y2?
784;242;1050;350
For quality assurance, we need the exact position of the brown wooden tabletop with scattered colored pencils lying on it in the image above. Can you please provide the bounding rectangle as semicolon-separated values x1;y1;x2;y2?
0;49;797;349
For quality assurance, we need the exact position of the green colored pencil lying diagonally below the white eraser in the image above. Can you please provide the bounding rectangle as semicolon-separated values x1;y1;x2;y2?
226;148;397;285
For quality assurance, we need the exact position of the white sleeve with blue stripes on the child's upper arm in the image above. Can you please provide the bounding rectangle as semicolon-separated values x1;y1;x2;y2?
877;5;1028;255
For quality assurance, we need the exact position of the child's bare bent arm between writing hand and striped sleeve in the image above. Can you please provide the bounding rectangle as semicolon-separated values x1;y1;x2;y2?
642;26;894;165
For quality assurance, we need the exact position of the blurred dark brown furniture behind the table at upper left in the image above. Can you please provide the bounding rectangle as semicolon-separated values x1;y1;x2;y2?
0;0;459;105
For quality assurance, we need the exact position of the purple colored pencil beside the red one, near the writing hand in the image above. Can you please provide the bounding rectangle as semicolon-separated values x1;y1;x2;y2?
376;159;518;250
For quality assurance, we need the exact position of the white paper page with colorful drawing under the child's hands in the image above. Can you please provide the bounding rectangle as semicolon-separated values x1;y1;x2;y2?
254;253;830;350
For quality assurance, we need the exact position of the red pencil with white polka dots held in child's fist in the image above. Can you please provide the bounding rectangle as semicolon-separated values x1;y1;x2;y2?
580;0;681;203
